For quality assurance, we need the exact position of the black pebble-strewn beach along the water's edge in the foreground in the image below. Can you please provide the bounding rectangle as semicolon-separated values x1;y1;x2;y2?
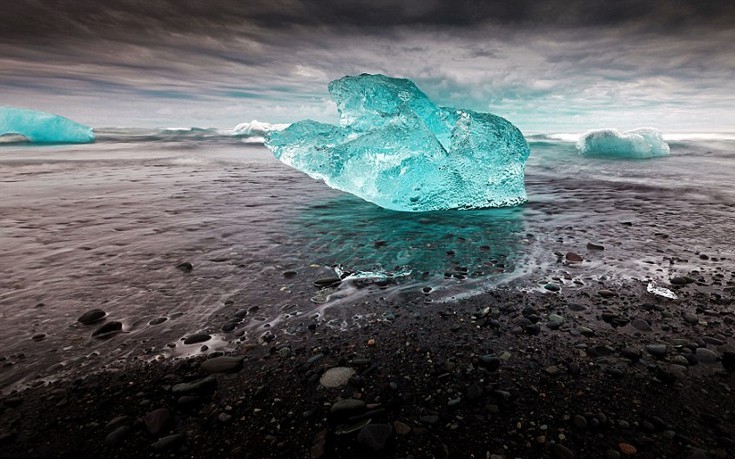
0;273;735;459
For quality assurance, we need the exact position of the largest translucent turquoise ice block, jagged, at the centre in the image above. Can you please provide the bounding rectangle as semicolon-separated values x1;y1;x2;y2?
265;74;530;212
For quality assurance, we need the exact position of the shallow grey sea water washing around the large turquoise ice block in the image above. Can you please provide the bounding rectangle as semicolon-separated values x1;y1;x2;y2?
0;135;735;389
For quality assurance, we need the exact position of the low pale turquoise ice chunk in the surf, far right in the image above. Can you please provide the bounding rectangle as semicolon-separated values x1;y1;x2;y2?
577;128;670;159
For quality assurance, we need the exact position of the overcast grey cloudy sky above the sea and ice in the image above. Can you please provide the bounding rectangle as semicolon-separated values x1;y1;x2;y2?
0;0;735;133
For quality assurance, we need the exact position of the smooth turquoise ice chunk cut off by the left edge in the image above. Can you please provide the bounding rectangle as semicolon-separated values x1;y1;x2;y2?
0;107;94;143
